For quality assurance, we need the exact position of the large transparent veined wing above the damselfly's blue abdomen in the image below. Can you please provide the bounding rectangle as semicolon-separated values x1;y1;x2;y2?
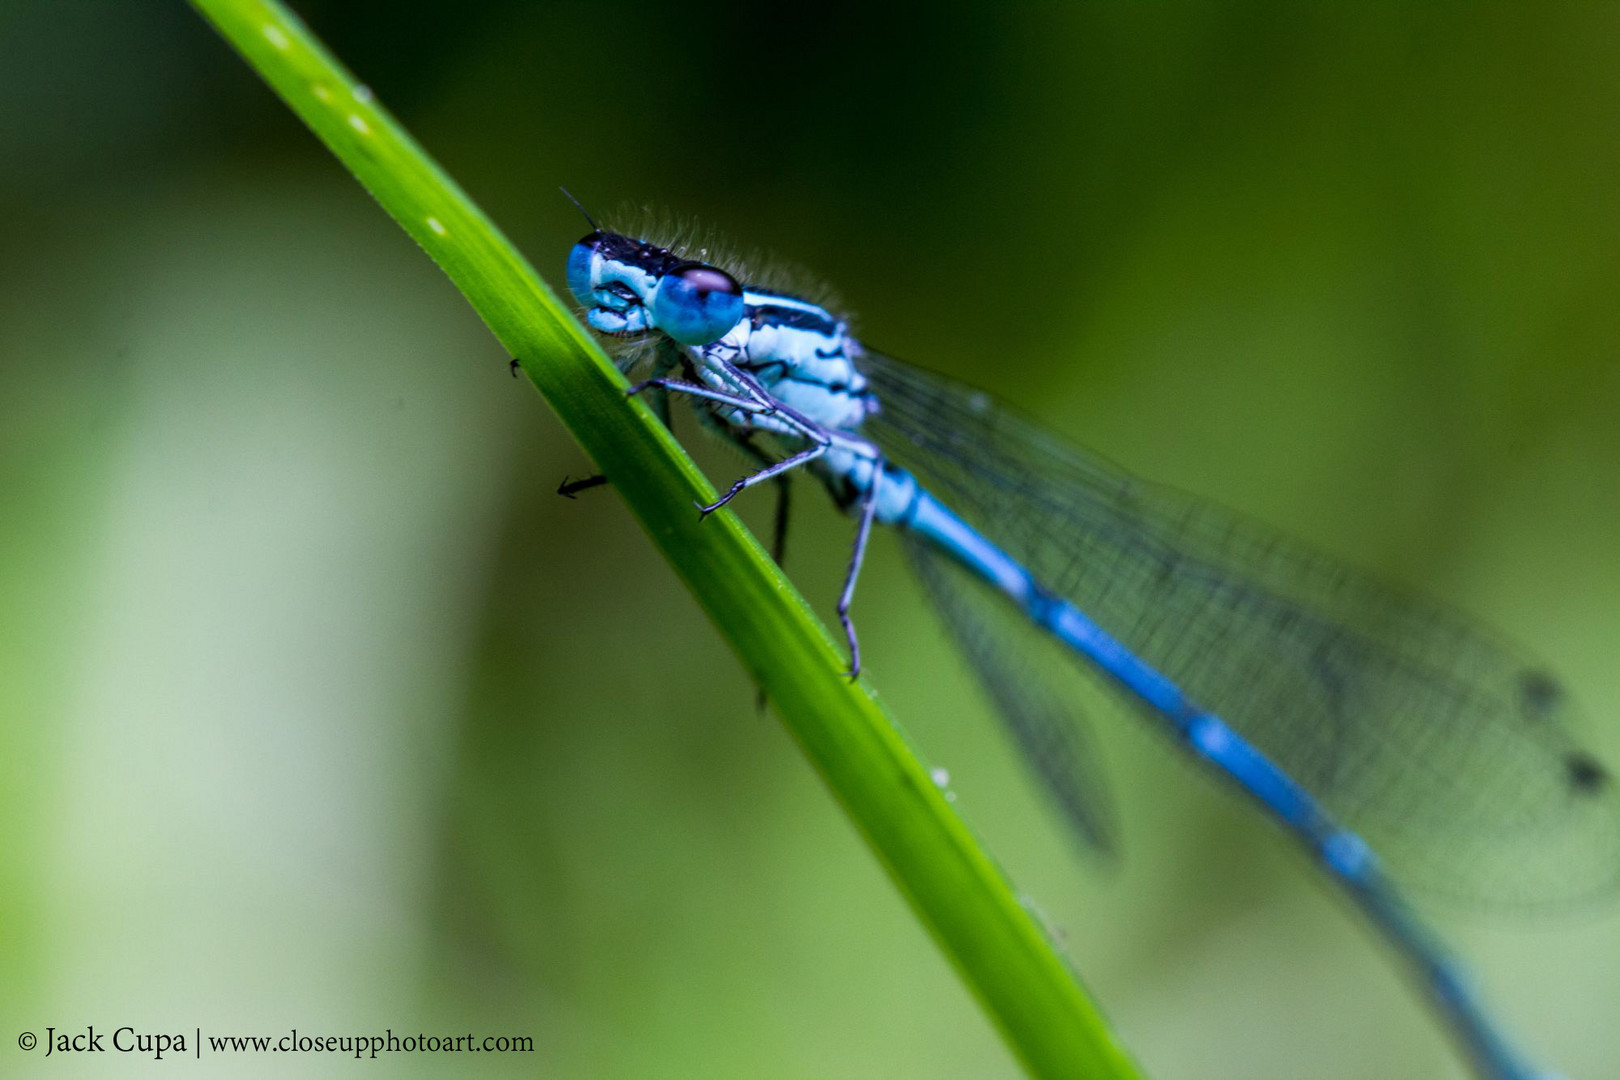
860;353;1620;907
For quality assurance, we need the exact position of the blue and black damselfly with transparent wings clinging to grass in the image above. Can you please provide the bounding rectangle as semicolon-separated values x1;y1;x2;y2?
567;204;1620;1080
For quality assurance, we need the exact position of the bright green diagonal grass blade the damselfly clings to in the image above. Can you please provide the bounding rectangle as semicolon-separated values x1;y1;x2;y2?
193;0;1137;1078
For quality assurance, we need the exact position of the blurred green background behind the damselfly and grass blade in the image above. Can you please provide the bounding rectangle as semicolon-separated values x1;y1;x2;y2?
0;0;1620;1080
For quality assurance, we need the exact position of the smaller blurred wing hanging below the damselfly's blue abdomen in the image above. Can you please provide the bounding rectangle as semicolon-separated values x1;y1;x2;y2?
906;536;1118;857
